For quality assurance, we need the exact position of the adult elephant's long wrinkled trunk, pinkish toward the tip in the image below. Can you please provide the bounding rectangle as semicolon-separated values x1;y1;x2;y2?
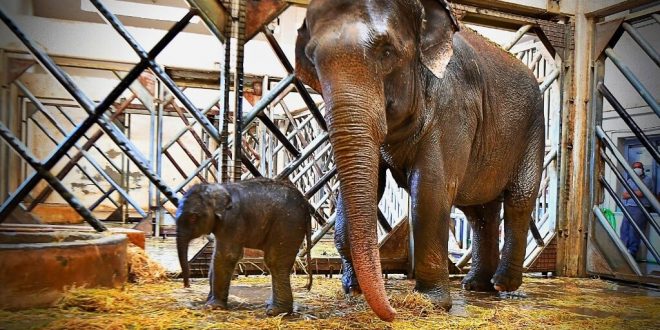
327;90;396;321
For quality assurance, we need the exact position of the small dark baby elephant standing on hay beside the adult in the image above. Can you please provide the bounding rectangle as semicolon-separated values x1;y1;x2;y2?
176;178;314;315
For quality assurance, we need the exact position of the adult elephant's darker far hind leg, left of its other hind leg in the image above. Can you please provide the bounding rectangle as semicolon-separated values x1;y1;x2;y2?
461;201;502;291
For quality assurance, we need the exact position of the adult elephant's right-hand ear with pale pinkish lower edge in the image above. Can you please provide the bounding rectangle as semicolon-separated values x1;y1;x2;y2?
420;0;459;78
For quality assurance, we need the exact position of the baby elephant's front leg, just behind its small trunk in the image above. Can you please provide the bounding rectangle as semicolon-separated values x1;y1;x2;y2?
206;240;243;309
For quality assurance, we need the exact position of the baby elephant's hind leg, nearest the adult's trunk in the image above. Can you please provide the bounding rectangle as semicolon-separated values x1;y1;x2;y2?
264;245;298;316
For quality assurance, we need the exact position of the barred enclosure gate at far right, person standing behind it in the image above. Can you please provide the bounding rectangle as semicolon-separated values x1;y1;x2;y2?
587;6;660;284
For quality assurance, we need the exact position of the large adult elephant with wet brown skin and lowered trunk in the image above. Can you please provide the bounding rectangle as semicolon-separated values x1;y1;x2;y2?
296;0;544;321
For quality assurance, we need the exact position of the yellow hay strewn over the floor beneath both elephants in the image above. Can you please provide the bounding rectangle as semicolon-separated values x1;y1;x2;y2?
0;276;660;330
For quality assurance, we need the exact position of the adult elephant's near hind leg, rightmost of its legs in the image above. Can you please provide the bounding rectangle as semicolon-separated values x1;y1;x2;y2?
491;144;543;291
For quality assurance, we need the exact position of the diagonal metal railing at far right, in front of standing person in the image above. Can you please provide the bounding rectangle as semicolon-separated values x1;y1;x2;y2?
588;13;660;281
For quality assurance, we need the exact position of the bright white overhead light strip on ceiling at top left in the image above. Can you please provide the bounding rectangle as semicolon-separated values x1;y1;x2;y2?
80;0;199;24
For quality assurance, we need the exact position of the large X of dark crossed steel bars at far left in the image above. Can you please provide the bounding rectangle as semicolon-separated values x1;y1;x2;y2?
0;6;183;222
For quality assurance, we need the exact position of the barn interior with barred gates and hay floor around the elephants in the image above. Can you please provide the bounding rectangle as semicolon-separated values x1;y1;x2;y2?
0;0;660;329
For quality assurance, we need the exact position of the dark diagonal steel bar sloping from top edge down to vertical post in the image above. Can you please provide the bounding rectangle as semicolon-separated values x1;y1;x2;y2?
90;0;220;144
